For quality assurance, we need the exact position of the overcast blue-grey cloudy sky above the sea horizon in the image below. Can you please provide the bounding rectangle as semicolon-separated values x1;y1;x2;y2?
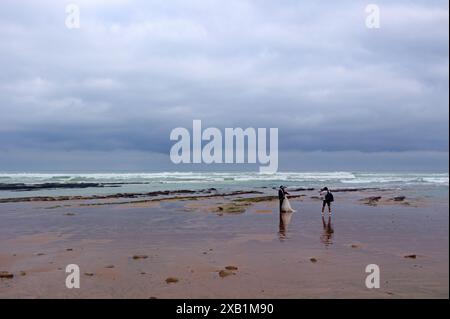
0;0;449;171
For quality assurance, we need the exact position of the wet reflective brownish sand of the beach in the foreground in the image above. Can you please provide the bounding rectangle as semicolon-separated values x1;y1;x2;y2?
0;190;449;298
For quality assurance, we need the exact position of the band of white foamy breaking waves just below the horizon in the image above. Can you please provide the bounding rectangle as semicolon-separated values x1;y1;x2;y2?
0;172;449;186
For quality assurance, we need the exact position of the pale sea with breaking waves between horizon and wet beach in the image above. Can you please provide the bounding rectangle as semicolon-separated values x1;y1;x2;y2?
0;172;449;198
